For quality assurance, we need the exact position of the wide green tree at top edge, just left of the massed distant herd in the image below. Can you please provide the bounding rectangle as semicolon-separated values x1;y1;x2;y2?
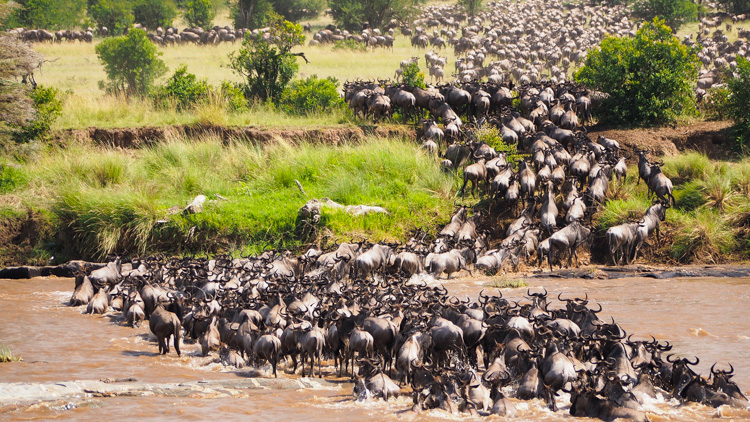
328;0;419;31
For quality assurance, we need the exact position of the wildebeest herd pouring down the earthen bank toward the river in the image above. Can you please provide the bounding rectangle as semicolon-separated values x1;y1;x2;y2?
345;78;675;276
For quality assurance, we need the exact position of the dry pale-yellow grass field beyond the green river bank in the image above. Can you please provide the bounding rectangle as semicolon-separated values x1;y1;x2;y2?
35;24;454;129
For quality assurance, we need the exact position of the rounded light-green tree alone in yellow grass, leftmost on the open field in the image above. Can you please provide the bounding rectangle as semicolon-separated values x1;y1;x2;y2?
96;29;167;95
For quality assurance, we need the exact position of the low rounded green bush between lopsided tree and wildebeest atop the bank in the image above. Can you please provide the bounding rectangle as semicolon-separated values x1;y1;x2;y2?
279;75;344;115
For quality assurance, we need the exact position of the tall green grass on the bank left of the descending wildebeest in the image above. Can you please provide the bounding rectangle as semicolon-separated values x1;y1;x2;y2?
0;138;456;259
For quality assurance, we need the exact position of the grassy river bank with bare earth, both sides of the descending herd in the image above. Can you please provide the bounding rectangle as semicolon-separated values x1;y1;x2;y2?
0;122;750;267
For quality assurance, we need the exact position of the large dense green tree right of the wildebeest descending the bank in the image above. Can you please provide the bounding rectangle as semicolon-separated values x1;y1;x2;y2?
575;18;699;126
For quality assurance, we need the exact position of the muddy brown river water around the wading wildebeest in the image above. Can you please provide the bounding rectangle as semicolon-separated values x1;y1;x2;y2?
0;278;750;422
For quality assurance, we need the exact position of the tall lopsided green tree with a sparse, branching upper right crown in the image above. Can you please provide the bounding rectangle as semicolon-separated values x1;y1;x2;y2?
229;20;307;103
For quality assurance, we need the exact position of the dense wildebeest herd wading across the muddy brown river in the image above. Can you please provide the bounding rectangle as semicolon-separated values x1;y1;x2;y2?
70;249;749;421
